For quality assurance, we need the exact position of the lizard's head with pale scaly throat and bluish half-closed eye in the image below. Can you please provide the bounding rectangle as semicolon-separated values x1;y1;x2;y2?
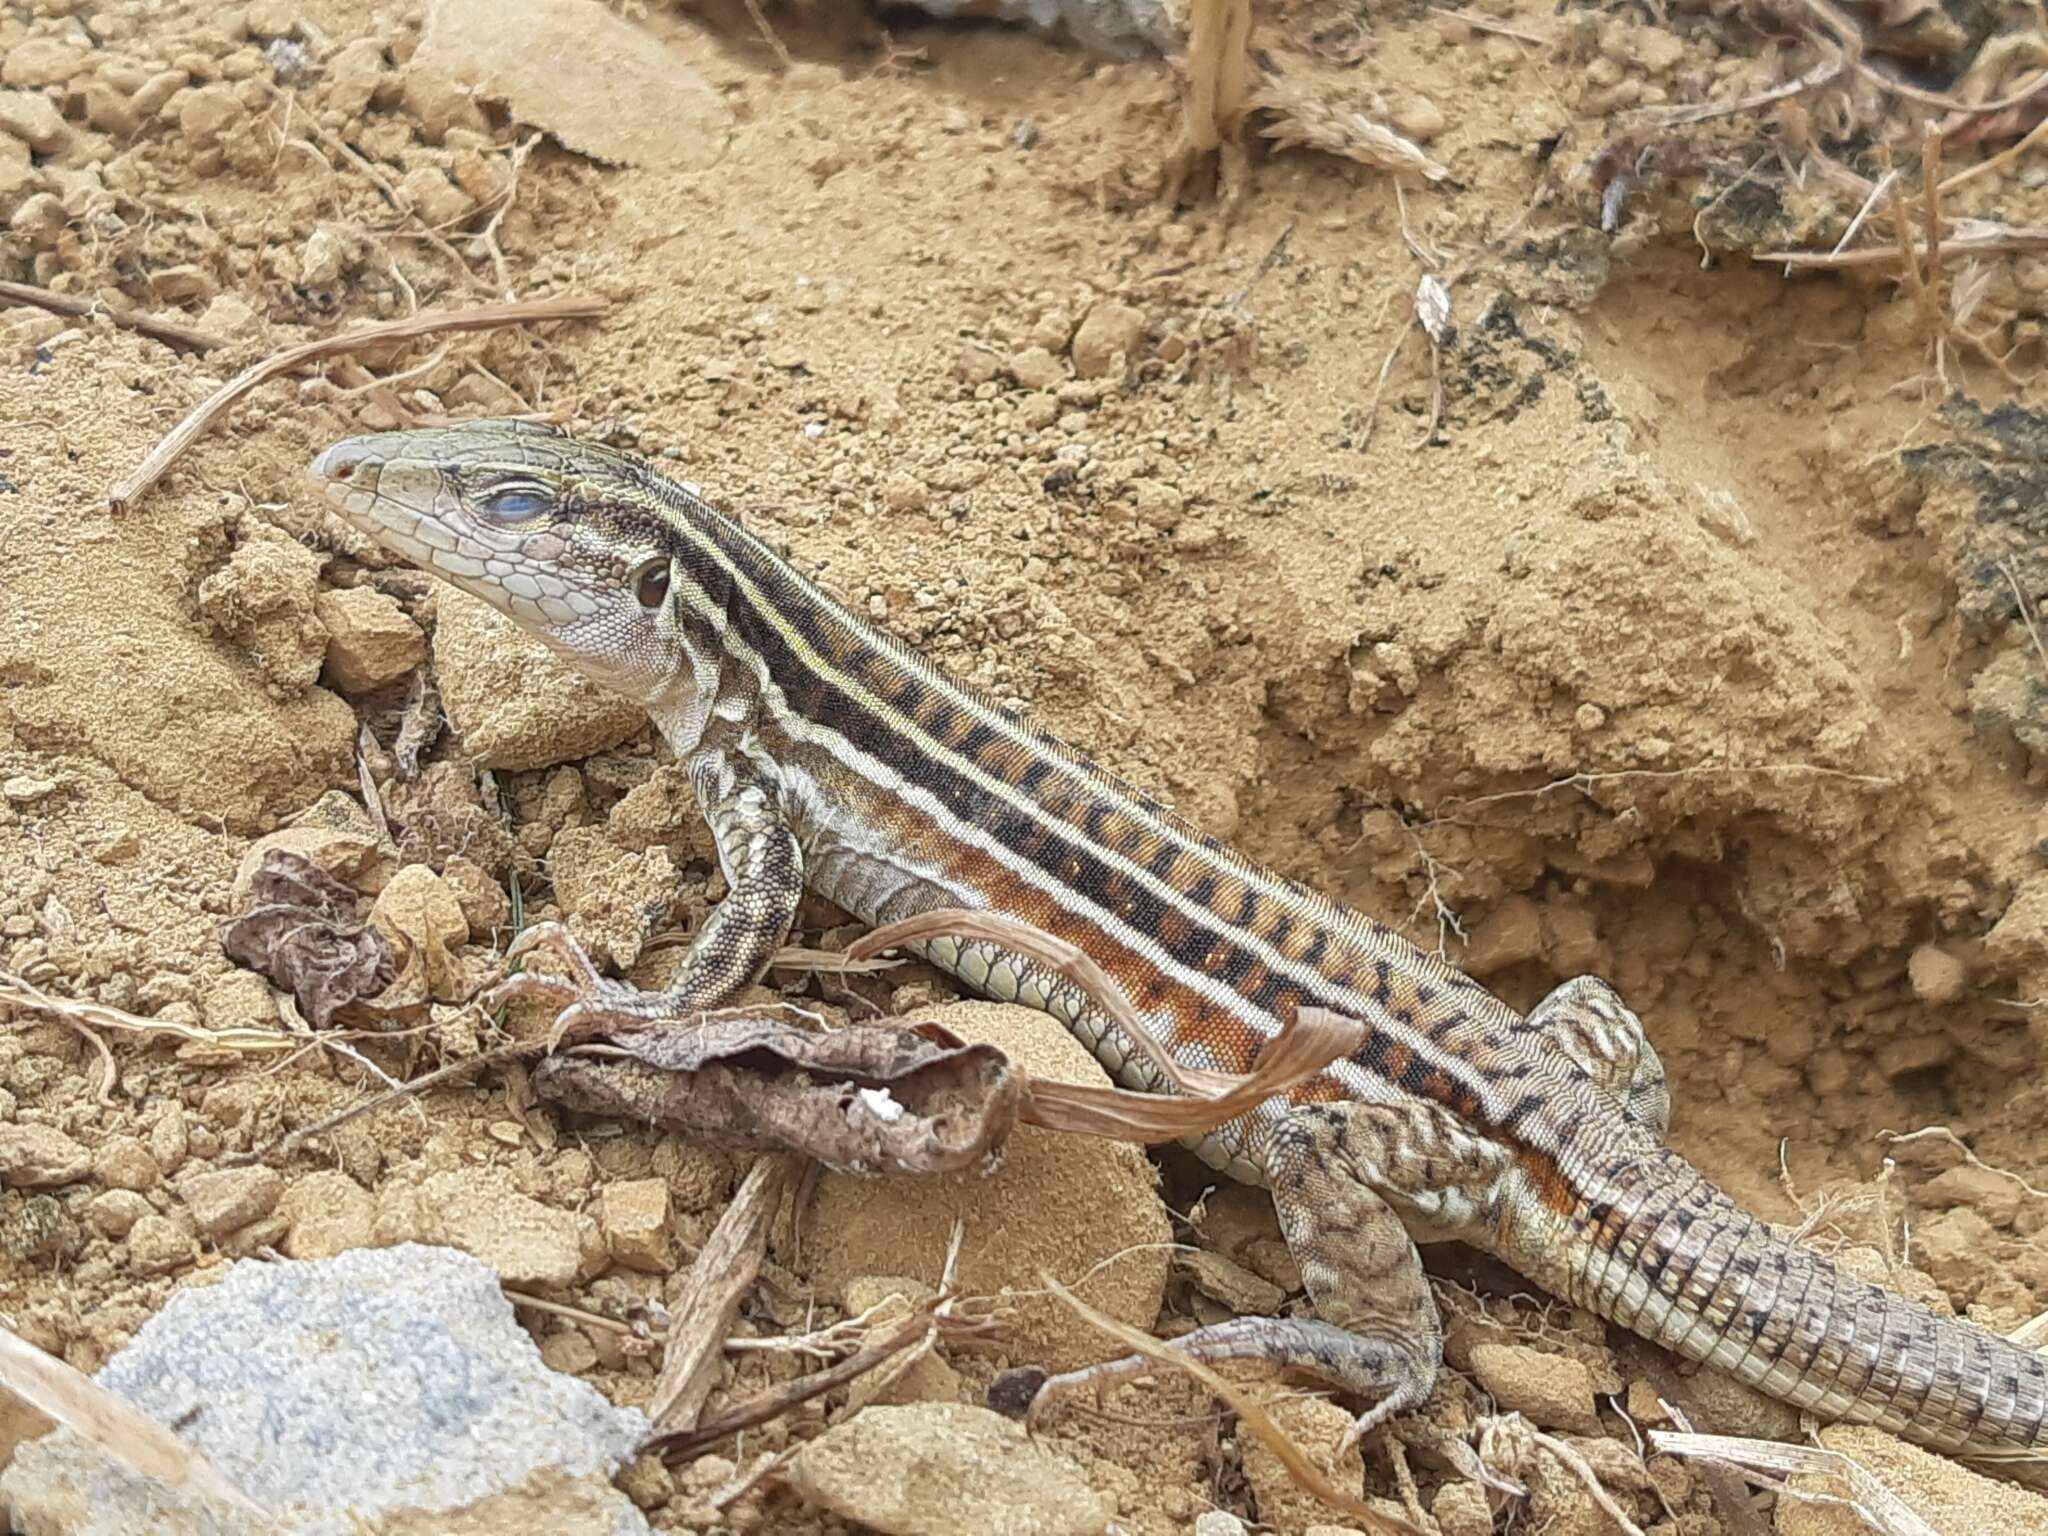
307;422;717;737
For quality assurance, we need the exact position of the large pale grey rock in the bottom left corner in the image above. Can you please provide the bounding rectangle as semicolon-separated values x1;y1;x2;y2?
0;1245;647;1536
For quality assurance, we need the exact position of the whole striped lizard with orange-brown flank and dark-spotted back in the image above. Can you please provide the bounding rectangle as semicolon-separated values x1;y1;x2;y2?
307;420;2048;1462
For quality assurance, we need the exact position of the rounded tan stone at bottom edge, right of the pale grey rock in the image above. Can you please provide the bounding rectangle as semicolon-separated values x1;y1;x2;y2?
788;1403;1116;1536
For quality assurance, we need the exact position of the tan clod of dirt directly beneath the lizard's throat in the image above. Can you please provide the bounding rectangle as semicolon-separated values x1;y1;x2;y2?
434;593;647;768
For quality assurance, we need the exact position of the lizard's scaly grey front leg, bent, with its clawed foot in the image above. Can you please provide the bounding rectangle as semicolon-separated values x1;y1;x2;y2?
485;754;803;1034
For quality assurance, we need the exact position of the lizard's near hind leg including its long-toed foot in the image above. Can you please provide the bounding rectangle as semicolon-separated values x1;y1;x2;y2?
991;1104;1444;1448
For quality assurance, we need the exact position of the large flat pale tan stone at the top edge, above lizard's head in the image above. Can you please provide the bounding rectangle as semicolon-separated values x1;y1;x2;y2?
408;0;733;170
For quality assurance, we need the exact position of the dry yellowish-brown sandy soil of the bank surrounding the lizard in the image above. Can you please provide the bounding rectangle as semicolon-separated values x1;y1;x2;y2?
0;0;2048;1532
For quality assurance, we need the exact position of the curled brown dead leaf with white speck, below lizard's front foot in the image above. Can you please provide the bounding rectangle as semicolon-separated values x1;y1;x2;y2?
532;1014;1024;1174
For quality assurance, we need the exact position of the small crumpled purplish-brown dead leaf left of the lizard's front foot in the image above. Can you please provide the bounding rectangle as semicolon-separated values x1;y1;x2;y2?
221;848;399;1030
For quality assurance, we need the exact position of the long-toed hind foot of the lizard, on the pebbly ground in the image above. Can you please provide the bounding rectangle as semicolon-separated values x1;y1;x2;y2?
989;1317;1436;1452
